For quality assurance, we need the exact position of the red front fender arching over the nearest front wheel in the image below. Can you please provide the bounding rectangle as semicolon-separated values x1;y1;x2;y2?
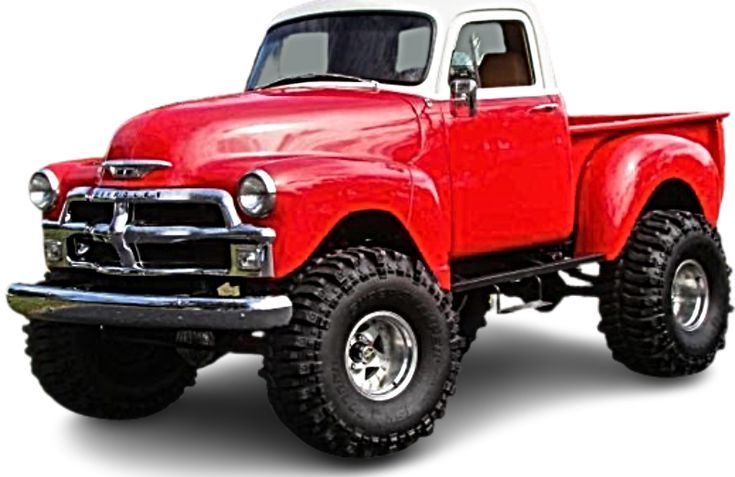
244;157;450;289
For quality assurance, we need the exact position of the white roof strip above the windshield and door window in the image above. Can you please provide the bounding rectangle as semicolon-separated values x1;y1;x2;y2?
274;0;534;25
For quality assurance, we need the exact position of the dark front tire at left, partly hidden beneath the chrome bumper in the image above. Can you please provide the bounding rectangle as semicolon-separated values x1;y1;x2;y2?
24;321;196;419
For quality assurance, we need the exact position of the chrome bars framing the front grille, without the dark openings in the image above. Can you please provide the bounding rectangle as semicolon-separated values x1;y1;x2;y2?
43;187;276;278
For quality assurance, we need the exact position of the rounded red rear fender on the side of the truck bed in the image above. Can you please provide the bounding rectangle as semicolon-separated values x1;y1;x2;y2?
576;134;723;260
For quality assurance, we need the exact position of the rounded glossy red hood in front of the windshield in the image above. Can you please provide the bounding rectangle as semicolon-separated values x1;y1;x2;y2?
103;88;421;187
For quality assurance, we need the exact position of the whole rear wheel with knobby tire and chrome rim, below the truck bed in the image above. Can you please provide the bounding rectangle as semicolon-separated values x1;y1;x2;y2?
600;211;731;377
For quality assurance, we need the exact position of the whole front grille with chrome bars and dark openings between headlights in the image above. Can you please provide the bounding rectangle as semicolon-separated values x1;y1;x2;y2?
44;188;275;277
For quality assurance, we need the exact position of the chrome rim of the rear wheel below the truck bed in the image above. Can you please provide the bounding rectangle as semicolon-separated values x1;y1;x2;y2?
671;260;709;333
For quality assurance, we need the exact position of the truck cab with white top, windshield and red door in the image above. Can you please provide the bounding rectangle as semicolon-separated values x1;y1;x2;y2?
249;2;575;258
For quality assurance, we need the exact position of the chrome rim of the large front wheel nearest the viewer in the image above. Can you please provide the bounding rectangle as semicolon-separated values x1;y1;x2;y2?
345;311;418;401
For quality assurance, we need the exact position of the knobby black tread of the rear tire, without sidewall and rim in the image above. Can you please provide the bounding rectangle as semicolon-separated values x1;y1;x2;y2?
599;211;731;377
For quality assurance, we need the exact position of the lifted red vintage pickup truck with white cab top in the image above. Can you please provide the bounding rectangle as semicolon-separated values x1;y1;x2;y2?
8;0;730;457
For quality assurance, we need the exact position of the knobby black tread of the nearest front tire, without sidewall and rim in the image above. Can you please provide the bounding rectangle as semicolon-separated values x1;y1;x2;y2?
262;247;462;457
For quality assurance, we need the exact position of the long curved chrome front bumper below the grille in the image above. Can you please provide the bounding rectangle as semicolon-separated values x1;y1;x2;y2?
7;284;292;331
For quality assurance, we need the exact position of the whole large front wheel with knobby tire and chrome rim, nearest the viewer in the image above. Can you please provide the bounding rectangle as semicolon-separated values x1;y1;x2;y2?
263;248;462;457
